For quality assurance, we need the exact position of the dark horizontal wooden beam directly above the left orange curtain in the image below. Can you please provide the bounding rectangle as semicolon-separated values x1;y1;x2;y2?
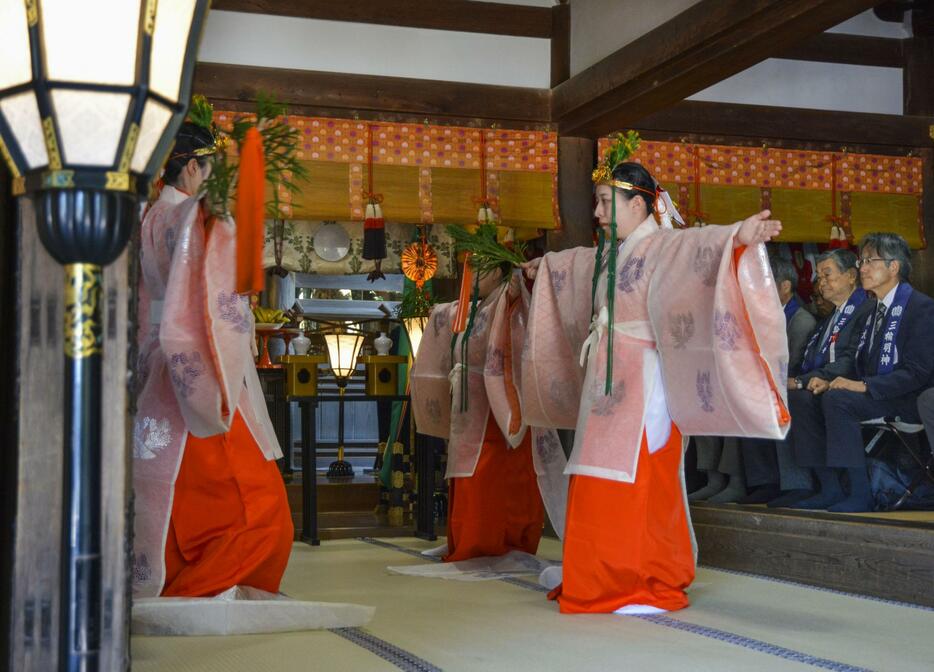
194;63;551;125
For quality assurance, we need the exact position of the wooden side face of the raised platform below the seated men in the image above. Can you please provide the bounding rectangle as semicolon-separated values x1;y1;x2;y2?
691;503;934;607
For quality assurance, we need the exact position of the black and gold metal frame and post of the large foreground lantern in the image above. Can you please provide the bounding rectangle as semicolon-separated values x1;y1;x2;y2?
0;0;209;672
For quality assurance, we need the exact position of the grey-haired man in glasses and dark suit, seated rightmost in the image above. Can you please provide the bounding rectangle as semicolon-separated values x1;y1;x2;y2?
789;233;934;512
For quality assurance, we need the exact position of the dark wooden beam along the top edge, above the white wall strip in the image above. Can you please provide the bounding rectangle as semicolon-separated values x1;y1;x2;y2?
211;0;552;39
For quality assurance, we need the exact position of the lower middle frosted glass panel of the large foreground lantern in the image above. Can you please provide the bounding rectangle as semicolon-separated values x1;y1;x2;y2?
52;89;130;166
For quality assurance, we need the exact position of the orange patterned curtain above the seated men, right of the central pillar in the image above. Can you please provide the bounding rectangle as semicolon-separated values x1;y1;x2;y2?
600;139;926;248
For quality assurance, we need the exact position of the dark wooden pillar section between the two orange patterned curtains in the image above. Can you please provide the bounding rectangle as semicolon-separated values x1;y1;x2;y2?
547;138;596;252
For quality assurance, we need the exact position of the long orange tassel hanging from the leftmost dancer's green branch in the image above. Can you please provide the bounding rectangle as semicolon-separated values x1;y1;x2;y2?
235;127;266;294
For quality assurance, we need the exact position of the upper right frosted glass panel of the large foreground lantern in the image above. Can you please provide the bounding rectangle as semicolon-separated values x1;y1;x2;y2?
149;0;195;102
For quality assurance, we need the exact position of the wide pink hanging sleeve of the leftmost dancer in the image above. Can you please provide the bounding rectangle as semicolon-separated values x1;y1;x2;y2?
159;198;258;440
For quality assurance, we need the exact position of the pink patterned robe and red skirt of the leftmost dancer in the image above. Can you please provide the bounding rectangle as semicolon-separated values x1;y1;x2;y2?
133;186;292;597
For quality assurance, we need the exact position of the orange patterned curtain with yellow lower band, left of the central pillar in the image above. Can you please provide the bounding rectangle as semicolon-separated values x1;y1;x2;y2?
215;111;560;232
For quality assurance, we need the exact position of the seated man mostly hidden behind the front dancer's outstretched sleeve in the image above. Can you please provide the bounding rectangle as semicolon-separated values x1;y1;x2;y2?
730;257;817;504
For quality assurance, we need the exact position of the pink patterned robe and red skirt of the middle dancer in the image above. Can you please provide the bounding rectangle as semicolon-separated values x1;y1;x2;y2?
412;275;567;559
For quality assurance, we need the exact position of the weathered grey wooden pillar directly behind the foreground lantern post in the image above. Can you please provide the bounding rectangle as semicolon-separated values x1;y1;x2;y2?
0;200;132;672
